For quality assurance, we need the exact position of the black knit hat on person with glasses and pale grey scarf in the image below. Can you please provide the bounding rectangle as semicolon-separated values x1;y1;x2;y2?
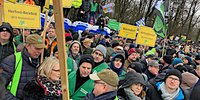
165;69;182;84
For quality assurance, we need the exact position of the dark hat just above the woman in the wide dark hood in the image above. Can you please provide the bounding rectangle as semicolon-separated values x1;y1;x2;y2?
128;62;143;73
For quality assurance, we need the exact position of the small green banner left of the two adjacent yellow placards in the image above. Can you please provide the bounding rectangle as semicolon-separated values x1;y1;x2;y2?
108;19;120;31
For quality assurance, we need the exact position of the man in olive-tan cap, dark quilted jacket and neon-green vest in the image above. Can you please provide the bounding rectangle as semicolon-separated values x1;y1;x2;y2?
0;34;45;100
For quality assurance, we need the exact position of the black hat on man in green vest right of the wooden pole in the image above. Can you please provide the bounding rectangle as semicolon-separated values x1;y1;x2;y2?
79;54;94;68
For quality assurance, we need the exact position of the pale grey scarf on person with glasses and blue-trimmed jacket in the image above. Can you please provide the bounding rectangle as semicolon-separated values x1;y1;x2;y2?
160;82;180;100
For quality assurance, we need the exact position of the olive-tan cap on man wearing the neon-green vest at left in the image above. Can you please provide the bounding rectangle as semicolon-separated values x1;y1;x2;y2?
26;34;45;48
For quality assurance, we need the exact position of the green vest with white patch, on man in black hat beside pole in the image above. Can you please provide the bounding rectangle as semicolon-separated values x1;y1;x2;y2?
68;71;94;100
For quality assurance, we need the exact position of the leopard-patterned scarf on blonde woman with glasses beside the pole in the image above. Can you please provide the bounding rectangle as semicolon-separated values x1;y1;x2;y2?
37;76;62;97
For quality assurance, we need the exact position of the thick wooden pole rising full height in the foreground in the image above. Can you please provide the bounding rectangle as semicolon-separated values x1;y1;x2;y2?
53;0;69;100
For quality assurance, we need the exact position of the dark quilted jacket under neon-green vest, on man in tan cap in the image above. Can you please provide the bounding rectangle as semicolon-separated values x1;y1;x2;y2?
0;48;39;100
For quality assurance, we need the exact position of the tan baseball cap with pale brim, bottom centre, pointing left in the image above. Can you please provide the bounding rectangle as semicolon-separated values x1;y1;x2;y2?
90;69;119;87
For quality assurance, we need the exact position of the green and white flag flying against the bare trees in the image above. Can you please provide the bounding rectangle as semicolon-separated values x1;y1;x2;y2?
153;0;167;38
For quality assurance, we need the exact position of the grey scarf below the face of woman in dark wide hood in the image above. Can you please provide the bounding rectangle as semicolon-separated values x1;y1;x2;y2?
124;88;142;100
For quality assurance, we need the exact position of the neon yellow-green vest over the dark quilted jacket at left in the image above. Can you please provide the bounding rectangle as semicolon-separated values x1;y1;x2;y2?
7;52;22;96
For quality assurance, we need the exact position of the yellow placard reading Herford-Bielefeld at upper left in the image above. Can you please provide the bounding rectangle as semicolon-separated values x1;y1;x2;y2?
4;2;41;29
